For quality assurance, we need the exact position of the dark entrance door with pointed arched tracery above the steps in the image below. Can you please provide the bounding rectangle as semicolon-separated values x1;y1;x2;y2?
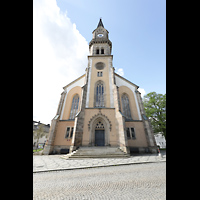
95;119;105;146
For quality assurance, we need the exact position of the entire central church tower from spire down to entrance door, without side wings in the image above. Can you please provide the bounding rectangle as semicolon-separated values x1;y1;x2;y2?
71;19;122;151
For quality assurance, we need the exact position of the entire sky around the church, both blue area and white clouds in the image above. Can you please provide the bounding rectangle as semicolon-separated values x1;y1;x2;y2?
33;0;166;124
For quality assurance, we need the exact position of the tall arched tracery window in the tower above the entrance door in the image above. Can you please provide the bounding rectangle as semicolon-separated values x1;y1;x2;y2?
95;81;105;107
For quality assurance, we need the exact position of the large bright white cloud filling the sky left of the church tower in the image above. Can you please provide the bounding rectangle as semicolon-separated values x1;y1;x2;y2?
33;0;89;123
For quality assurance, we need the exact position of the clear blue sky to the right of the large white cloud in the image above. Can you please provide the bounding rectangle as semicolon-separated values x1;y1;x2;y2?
57;0;166;94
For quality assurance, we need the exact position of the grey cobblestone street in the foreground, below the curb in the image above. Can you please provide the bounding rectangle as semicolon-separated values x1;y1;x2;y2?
33;162;166;200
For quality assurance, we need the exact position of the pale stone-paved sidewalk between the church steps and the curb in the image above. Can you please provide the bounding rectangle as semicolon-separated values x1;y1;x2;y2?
33;151;166;173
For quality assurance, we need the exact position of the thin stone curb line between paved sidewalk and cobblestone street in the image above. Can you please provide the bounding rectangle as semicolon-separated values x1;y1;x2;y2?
33;159;166;173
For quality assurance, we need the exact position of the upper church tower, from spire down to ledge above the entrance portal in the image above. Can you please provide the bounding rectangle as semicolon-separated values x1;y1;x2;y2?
86;19;114;108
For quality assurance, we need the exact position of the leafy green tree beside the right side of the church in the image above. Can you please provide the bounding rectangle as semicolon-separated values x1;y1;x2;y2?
143;92;166;139
